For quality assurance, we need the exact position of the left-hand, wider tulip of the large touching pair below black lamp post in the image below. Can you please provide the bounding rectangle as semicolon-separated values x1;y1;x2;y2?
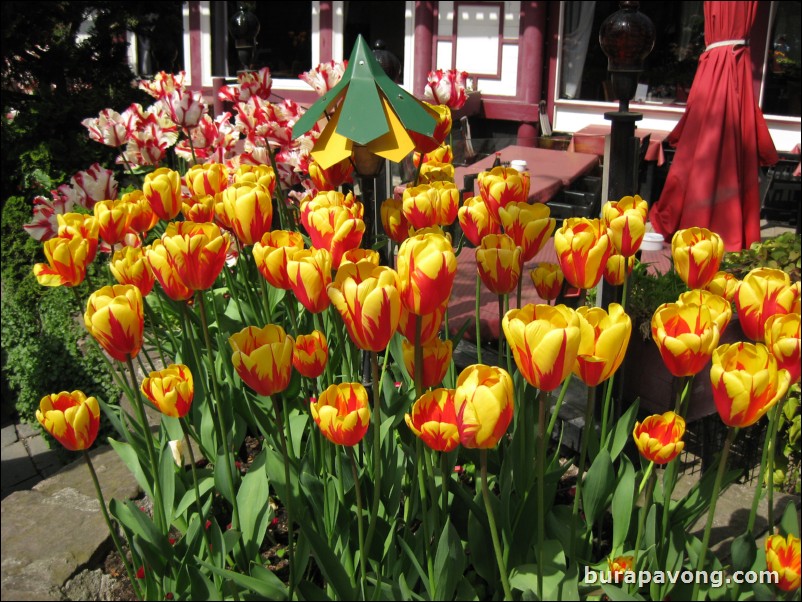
501;304;582;391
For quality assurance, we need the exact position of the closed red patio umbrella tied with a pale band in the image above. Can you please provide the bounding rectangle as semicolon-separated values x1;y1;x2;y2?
649;2;778;251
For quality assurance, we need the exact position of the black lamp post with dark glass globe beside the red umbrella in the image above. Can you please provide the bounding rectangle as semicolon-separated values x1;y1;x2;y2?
599;2;655;200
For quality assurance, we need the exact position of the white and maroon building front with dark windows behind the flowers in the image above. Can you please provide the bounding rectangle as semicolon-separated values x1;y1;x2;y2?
172;0;802;151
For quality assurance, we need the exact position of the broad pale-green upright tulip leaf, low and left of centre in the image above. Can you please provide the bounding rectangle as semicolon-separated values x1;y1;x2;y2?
237;450;272;556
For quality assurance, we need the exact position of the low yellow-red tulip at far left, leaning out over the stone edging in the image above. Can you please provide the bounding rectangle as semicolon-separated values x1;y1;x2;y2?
36;391;100;451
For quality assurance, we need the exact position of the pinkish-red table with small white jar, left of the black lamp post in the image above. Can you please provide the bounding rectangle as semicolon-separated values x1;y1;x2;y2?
454;145;599;203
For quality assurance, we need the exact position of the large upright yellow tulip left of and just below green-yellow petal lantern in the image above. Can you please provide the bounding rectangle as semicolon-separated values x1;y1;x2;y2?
221;180;273;245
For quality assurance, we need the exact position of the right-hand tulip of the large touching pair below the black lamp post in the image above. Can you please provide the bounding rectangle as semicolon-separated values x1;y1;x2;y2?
574;303;632;387
